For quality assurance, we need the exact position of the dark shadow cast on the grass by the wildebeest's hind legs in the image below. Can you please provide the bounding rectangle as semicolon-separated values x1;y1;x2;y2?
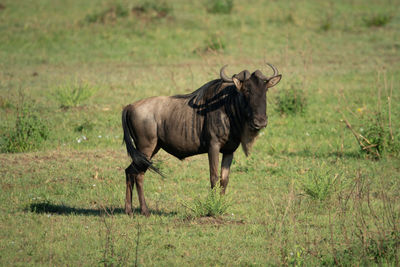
27;202;177;217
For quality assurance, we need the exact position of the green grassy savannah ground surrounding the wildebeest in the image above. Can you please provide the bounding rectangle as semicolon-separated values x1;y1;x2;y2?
0;0;400;266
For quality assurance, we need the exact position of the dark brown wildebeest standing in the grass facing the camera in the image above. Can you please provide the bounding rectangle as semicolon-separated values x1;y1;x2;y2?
122;63;281;216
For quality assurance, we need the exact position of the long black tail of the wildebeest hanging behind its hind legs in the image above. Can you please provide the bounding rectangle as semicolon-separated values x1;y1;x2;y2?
122;108;164;176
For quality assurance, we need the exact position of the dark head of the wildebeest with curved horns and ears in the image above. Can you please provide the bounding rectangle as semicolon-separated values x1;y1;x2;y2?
220;63;282;130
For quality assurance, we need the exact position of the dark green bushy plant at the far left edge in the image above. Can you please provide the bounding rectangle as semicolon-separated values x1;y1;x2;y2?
1;106;49;153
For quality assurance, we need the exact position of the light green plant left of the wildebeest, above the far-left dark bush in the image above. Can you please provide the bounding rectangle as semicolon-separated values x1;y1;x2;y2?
55;82;97;108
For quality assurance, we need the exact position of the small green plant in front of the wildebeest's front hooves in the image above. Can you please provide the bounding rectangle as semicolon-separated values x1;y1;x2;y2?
186;186;231;217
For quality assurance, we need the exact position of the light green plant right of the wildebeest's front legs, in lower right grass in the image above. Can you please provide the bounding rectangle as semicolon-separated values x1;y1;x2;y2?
302;168;338;201
